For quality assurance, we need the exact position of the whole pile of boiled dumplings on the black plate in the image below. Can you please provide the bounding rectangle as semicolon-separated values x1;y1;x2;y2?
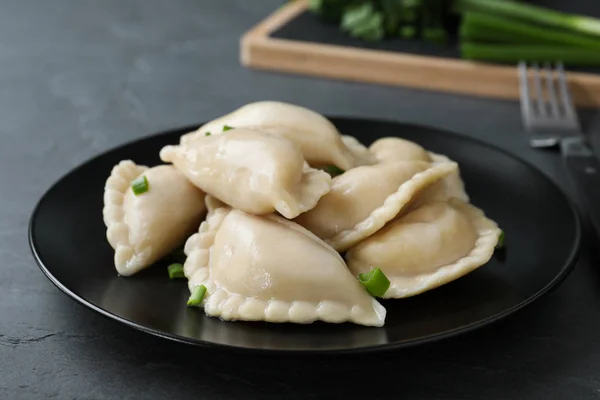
103;101;501;326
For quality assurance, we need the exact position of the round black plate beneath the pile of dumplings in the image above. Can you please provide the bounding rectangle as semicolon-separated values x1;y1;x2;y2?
29;118;580;352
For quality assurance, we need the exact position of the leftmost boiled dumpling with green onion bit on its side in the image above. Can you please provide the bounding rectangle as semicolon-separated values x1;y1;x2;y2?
102;160;206;276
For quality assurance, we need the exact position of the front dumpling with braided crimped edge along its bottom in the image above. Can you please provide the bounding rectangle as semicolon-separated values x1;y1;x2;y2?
184;208;386;326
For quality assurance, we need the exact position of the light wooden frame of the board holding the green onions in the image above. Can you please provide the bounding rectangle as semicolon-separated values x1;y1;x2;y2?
240;0;600;107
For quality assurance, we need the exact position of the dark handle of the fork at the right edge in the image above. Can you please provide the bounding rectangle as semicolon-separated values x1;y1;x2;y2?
563;152;600;238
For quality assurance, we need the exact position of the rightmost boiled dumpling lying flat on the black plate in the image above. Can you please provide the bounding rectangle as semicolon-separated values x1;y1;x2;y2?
346;199;500;298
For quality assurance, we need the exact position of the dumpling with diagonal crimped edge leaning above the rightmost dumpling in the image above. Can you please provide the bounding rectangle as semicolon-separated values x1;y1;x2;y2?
295;161;457;251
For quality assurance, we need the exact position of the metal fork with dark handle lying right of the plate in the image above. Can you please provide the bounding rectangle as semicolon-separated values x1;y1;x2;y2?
518;62;600;236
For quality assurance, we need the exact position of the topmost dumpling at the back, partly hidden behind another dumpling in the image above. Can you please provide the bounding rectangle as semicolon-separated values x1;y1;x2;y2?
181;101;376;171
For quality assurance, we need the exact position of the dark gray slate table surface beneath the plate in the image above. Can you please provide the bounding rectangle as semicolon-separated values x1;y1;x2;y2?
0;0;600;400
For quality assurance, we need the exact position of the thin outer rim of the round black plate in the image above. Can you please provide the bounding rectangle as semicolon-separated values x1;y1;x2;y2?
27;115;582;355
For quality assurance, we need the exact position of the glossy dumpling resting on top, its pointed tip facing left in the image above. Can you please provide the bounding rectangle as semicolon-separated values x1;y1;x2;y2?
160;129;331;218
